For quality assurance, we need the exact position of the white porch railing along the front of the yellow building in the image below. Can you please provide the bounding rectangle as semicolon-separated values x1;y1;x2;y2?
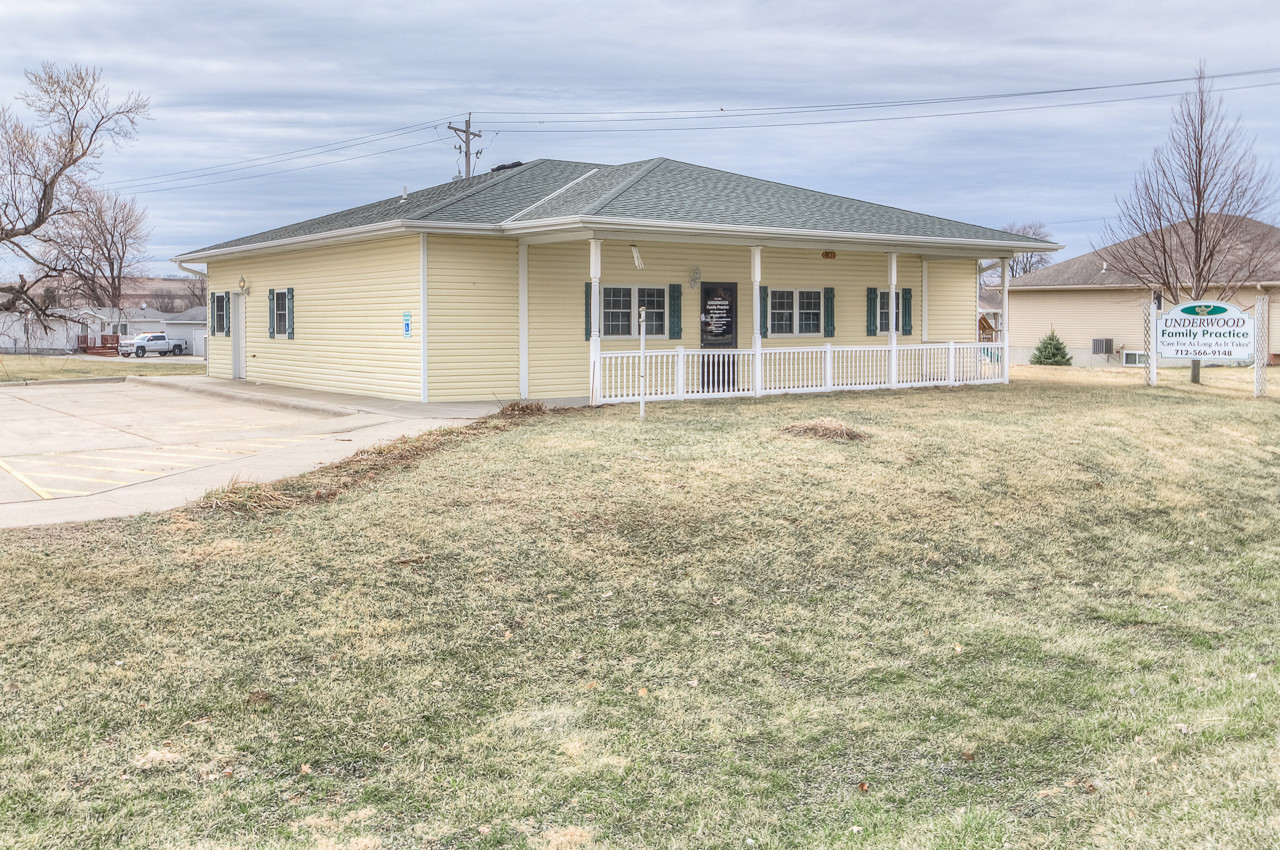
598;342;1006;405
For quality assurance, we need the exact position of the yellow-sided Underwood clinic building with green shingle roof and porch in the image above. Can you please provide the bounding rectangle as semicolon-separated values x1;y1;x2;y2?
175;159;1060;403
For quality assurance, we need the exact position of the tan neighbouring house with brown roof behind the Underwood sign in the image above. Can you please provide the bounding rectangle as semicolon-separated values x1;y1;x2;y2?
1009;223;1280;366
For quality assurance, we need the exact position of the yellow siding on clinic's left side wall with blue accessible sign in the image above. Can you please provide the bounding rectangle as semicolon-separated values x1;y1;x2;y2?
209;236;422;399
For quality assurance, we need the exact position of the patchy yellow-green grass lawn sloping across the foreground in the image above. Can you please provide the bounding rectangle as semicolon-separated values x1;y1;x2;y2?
0;369;1280;850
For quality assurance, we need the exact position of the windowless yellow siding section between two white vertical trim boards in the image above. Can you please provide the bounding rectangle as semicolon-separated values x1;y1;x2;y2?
426;234;514;402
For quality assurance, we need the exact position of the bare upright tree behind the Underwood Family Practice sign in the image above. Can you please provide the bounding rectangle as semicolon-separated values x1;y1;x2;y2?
1097;63;1280;383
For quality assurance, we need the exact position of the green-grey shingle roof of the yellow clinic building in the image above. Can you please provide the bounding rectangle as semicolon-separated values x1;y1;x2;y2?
177;159;1061;261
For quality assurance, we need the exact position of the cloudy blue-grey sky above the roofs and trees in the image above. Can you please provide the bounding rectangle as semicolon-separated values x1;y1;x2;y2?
0;0;1280;277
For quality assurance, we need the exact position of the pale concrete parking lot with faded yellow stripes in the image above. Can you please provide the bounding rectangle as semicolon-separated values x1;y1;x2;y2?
0;376;485;527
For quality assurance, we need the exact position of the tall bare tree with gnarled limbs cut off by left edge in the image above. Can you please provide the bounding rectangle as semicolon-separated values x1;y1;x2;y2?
0;63;150;320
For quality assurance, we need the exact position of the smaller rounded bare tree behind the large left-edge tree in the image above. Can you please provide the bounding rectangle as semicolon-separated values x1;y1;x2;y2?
47;187;151;316
